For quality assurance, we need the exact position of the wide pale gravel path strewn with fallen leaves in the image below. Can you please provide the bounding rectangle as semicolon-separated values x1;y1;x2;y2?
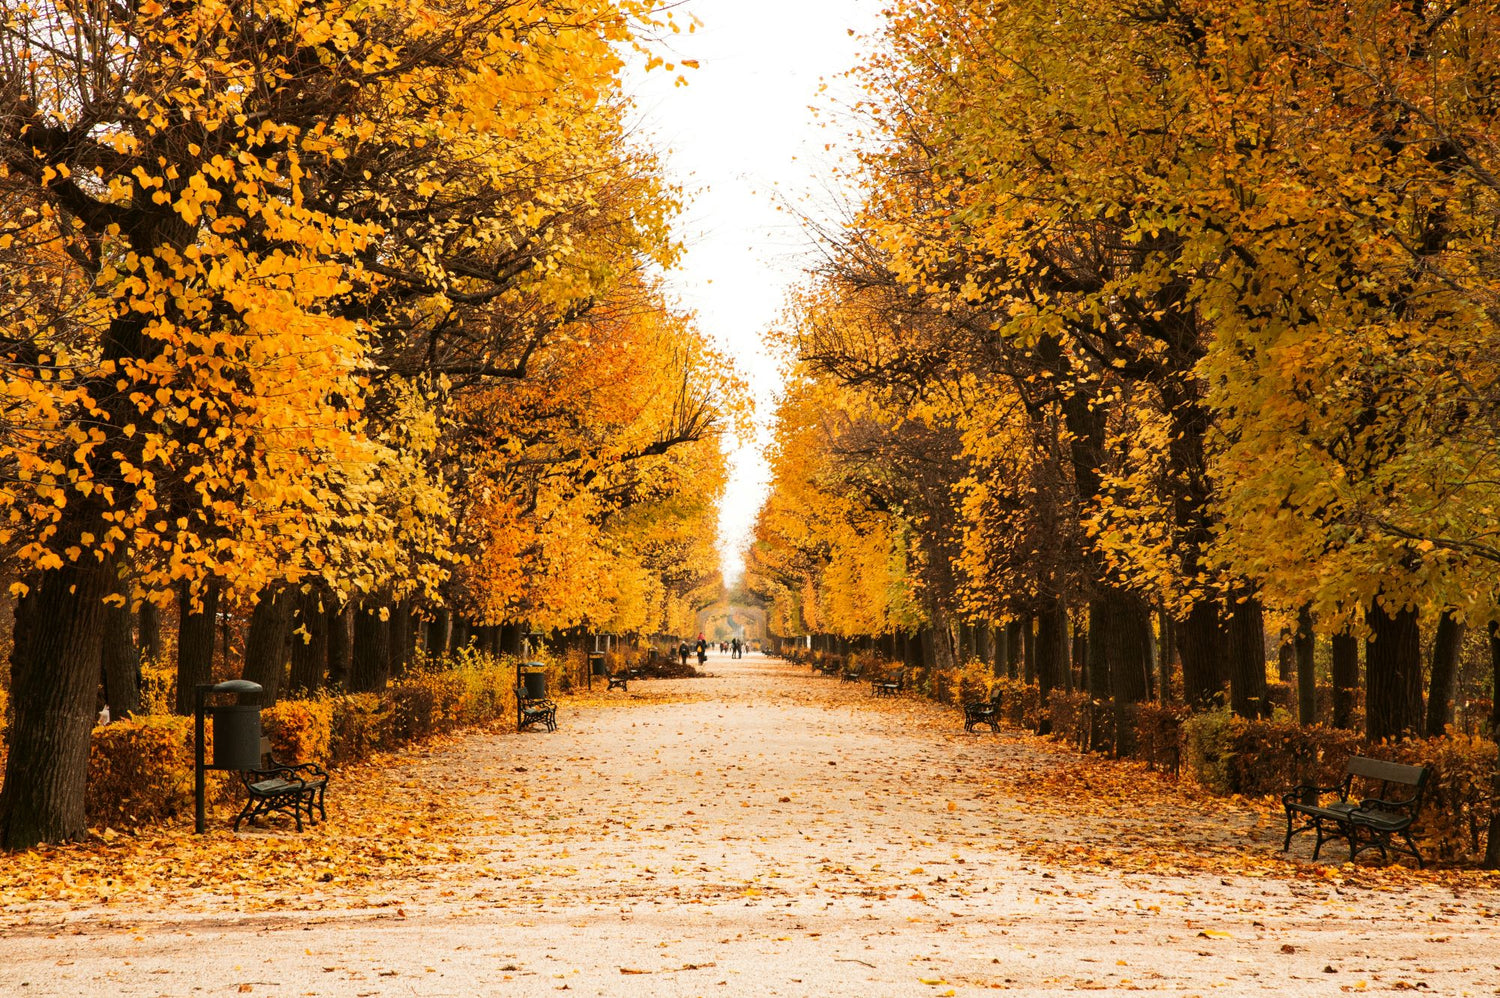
0;656;1500;998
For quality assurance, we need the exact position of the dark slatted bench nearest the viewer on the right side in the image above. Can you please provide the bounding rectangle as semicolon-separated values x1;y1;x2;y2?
1281;755;1428;867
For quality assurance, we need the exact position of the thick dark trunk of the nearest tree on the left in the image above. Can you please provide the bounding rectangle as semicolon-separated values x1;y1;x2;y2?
0;558;114;849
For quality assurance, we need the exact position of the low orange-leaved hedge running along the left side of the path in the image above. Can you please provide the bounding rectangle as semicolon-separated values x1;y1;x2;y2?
86;650;540;827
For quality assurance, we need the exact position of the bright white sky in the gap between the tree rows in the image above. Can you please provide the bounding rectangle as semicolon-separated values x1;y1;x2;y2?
627;0;881;585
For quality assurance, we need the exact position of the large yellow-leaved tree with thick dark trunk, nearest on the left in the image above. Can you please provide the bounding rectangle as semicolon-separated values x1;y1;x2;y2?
0;0;714;846
